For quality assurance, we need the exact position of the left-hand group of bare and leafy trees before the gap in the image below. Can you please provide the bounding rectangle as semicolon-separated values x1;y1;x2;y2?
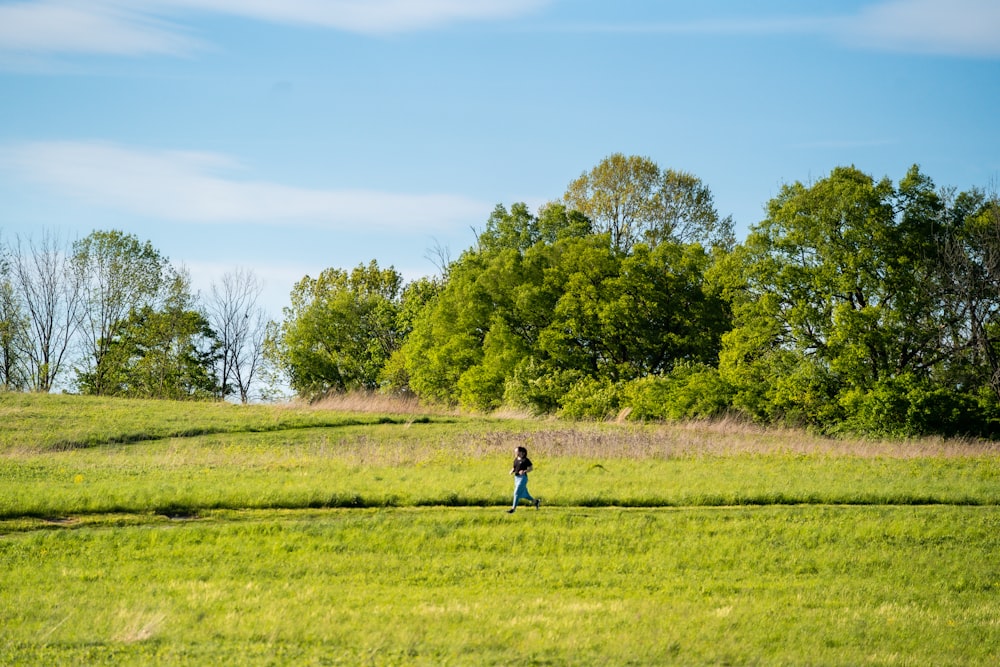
0;230;267;403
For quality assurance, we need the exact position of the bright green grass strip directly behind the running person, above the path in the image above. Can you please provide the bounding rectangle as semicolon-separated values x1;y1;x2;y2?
0;420;1000;519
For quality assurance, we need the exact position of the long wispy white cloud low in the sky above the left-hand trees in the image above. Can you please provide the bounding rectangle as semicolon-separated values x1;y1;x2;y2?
0;142;492;231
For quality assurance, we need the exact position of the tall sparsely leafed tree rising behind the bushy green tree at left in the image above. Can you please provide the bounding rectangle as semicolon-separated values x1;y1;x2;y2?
73;230;167;394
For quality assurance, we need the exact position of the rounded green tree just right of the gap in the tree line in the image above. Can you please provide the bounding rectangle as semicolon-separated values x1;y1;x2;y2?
269;261;403;397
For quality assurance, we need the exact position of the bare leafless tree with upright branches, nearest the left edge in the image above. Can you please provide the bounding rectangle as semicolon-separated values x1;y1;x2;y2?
12;232;80;392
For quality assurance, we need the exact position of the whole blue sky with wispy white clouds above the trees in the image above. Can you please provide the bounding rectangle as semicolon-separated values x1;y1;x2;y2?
0;0;1000;319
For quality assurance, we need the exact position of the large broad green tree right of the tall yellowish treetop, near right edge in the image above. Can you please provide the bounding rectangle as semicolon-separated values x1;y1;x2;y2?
713;167;980;429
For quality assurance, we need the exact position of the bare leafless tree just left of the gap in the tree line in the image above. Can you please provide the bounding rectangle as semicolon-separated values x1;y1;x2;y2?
206;268;267;403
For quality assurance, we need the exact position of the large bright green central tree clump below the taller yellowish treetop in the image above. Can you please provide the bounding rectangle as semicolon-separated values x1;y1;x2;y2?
390;204;728;415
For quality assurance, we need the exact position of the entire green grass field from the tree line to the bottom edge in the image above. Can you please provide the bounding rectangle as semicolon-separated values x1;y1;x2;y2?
0;395;1000;665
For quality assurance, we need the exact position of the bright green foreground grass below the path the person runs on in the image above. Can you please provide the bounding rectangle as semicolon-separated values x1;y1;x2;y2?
0;506;1000;665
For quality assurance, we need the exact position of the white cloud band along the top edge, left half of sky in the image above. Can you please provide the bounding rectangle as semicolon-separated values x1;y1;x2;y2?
0;0;551;55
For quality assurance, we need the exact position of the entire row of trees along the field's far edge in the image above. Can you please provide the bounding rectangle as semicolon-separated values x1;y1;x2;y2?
7;154;1000;438
